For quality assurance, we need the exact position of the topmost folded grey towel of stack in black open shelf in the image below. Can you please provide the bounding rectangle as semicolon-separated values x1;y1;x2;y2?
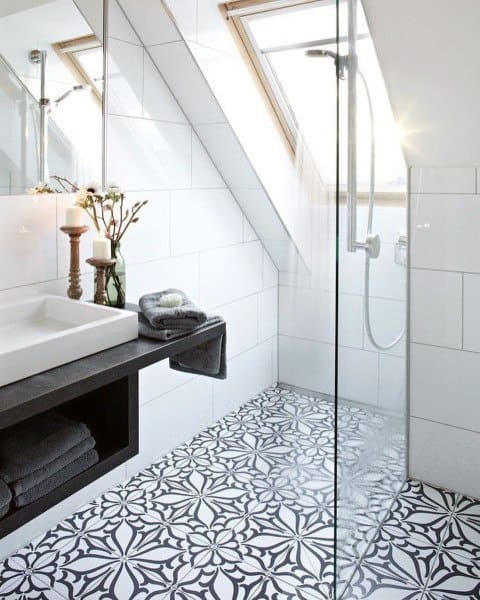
0;411;90;483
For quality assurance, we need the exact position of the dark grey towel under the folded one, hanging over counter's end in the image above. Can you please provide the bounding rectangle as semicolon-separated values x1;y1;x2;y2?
138;314;227;379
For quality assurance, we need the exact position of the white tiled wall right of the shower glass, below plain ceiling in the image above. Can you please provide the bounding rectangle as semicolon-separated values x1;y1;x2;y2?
410;167;480;497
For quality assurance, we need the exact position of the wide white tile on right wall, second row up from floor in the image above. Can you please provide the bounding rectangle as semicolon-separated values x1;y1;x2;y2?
410;344;480;432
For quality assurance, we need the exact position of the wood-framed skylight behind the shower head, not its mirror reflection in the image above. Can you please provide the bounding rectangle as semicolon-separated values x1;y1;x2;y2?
227;0;405;192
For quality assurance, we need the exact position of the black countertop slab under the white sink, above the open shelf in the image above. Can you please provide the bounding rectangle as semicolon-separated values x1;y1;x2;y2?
0;306;226;429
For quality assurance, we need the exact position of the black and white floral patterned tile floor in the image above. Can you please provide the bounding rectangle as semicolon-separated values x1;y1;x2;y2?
0;388;480;600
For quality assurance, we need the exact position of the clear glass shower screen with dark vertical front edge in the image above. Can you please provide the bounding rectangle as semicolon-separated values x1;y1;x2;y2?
335;0;407;599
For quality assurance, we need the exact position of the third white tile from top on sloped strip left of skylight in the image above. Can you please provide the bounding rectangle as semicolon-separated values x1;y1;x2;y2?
194;123;261;189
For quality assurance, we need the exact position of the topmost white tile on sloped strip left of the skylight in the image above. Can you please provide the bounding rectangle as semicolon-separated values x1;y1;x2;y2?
120;0;180;46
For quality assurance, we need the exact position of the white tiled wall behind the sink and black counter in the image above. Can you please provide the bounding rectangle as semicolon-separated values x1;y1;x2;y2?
0;2;278;555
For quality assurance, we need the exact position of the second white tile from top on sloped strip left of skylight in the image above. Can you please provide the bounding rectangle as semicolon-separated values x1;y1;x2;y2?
148;42;225;123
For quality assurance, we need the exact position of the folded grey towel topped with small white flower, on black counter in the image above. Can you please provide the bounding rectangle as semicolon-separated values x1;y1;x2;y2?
138;289;207;332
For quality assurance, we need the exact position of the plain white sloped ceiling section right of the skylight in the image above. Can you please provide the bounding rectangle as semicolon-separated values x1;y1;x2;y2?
363;0;480;166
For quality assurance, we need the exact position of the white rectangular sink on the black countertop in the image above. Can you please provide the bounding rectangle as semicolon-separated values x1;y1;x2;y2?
0;296;138;386
